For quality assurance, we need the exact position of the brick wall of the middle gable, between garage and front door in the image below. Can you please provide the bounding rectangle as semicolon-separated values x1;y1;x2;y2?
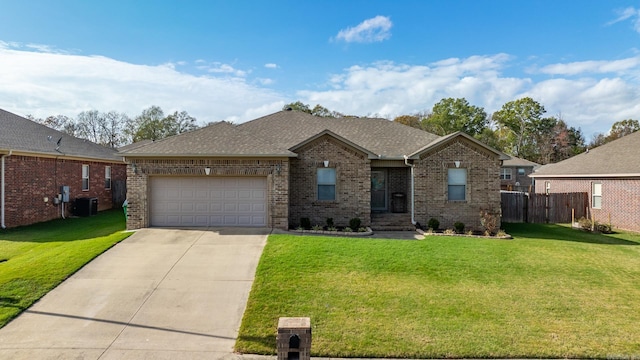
289;135;371;226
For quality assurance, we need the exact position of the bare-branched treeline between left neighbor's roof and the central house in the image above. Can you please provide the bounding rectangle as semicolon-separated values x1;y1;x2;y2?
27;105;199;148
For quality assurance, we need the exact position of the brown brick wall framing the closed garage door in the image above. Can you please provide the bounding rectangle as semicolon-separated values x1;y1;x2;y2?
127;158;289;229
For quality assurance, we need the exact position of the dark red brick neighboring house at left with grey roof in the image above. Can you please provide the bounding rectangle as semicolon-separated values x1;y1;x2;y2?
0;110;126;228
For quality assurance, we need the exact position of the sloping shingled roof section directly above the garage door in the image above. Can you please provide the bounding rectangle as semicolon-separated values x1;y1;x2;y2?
120;122;295;157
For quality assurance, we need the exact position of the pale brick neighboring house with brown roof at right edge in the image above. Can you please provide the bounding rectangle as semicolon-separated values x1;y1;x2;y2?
530;132;640;231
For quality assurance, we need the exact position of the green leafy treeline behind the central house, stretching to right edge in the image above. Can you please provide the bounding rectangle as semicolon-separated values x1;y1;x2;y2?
284;97;640;164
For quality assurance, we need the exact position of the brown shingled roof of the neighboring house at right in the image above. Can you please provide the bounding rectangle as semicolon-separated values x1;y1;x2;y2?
530;131;640;178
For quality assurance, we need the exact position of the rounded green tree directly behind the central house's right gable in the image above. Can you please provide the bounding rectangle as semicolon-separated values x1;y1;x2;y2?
422;98;489;136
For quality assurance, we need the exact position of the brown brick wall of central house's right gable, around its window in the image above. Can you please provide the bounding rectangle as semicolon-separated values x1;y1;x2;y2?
414;139;500;230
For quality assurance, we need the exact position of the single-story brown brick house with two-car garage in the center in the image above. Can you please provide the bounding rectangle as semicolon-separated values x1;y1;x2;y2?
121;110;508;230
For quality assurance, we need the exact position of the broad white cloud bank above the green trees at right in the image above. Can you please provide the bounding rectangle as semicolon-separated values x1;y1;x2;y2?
298;54;640;140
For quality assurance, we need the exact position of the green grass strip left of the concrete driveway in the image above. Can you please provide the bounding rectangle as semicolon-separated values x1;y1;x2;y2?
0;210;130;328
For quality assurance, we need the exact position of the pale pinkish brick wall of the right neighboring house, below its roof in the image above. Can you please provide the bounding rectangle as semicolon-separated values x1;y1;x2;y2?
535;178;640;232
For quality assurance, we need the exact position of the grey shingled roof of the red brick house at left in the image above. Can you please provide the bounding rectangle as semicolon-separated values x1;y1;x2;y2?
0;109;122;162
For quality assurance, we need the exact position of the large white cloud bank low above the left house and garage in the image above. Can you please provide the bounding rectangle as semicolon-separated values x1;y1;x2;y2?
0;43;283;123
